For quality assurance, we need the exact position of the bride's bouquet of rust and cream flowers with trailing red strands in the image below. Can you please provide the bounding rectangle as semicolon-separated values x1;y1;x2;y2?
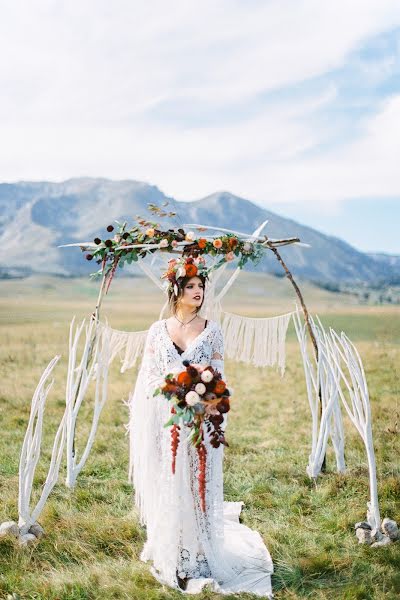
154;360;231;512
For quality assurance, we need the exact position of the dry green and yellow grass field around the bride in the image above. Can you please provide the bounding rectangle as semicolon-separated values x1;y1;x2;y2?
0;274;400;600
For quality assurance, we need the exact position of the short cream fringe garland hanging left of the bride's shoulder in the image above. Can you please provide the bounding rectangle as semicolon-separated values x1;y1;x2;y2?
99;322;147;373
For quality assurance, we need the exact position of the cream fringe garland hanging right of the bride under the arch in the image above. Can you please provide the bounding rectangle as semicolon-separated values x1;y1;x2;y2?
222;312;293;375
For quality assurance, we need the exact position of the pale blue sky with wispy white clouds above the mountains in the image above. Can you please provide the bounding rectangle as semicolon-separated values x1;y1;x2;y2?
0;0;400;254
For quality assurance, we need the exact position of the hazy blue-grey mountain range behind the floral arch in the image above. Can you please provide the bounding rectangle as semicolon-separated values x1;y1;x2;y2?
0;178;400;284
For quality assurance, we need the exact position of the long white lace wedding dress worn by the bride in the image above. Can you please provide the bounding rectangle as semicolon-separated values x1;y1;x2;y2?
129;319;273;598
